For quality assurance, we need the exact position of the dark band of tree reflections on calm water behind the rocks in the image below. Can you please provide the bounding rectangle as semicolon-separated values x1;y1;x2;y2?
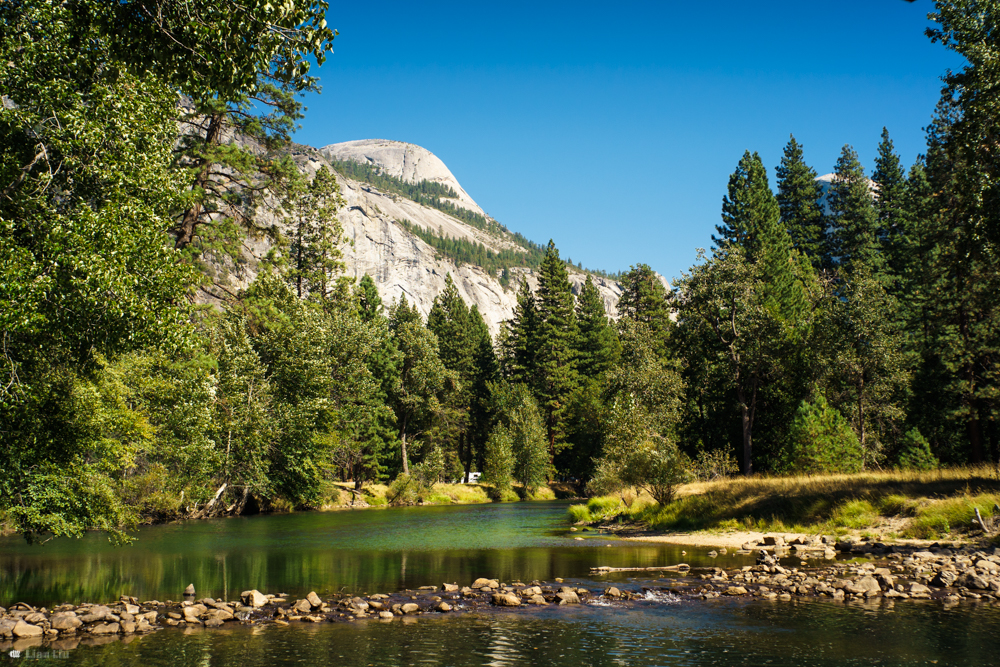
0;546;729;604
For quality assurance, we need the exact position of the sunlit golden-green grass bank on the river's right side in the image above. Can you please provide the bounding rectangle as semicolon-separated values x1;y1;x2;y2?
571;467;1000;539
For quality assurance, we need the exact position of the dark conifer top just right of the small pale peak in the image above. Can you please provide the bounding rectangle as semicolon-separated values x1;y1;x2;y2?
827;146;884;275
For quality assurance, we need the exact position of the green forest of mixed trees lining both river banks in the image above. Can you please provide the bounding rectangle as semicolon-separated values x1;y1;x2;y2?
0;0;1000;539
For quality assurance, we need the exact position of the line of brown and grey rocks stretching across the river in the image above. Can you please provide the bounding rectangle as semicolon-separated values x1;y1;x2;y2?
0;536;1000;651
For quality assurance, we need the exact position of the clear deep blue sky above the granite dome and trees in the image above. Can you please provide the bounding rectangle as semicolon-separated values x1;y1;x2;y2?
296;0;961;277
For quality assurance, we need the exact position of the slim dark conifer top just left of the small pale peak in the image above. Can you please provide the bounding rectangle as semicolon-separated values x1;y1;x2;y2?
775;136;828;270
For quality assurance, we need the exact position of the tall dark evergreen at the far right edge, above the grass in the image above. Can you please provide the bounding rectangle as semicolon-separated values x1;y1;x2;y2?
918;83;1000;462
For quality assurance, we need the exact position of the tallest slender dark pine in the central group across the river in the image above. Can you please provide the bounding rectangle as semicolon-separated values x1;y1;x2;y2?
535;240;578;457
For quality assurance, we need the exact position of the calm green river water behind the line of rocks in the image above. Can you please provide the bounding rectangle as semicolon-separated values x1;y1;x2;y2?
0;502;750;604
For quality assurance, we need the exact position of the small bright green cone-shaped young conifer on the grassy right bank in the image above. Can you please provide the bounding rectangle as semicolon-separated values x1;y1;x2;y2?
785;392;864;474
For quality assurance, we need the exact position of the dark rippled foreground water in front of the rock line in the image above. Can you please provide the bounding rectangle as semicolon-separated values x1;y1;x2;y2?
9;600;1000;667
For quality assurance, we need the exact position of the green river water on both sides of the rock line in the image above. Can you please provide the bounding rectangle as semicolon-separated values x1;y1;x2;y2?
0;503;1000;667
